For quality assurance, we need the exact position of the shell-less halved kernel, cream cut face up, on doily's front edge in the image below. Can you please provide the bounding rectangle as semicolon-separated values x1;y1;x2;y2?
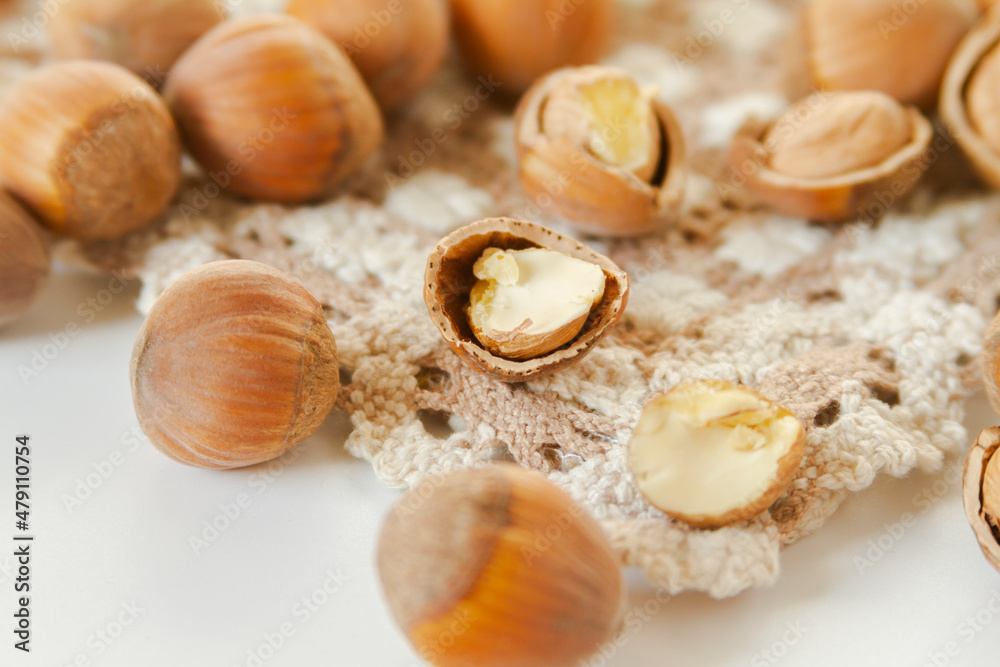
629;380;805;528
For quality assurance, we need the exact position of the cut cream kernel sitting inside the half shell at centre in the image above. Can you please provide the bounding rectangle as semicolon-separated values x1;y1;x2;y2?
467;248;604;359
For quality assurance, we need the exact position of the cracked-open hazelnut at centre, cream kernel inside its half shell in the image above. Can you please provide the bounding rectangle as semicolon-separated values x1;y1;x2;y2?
424;218;628;382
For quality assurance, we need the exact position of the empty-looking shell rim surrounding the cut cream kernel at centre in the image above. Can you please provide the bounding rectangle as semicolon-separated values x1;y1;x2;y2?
424;218;629;382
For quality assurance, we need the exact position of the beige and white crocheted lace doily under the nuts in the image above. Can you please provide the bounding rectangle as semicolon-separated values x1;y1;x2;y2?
9;0;1000;596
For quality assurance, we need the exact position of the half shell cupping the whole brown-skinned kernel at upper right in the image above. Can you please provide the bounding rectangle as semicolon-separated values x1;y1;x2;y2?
729;93;934;222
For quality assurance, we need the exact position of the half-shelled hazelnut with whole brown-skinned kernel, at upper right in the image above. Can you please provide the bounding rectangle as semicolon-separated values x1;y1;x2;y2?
730;91;934;222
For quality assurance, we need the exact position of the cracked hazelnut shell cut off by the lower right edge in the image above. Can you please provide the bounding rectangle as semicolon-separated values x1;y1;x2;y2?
962;426;1000;572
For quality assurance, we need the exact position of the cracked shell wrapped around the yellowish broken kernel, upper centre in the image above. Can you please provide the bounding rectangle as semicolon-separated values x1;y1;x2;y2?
514;66;687;236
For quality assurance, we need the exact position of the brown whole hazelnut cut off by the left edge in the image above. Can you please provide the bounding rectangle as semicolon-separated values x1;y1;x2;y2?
0;192;51;326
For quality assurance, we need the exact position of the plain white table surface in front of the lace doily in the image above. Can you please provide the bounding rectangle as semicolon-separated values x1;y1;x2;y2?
0;272;1000;667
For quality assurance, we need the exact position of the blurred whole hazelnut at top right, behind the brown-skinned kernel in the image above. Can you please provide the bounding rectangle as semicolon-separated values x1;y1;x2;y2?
793;0;977;106
